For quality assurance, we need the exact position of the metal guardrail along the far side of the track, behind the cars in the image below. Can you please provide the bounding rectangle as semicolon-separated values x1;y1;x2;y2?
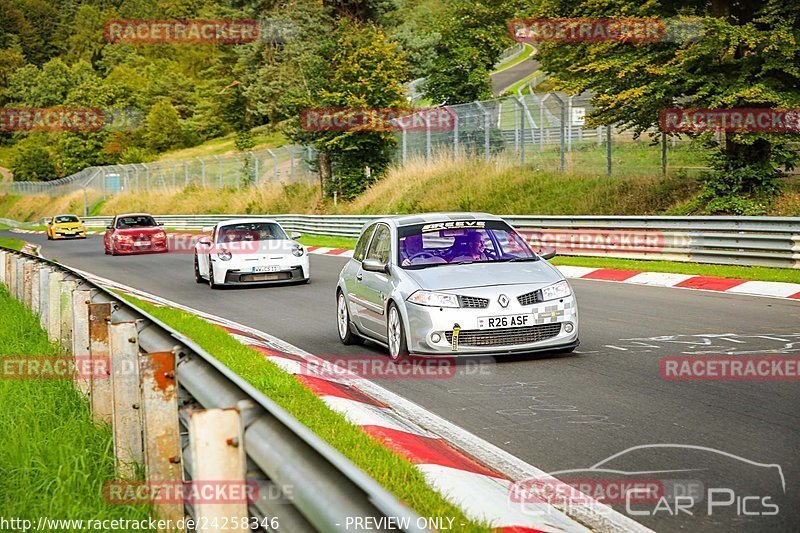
75;214;800;268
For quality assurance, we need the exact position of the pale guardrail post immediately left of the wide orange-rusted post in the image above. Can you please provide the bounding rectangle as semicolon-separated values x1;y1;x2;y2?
109;322;144;478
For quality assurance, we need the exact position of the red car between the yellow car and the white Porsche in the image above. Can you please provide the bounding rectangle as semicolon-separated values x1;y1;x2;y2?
103;213;169;255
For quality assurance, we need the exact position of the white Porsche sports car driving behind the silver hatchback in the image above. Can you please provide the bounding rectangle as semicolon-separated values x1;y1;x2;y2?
194;218;310;289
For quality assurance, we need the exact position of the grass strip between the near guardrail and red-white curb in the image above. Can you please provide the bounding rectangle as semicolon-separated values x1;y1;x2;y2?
120;295;491;531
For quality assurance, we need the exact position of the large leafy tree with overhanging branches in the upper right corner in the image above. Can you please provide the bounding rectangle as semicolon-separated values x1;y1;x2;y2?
529;0;800;214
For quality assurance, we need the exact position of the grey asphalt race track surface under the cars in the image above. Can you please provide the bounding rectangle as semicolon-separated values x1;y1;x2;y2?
14;232;800;531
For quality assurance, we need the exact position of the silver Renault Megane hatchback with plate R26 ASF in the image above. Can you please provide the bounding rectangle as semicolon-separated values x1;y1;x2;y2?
336;213;578;359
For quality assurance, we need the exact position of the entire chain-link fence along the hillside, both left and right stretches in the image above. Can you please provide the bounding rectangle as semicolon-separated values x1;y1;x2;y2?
0;91;705;201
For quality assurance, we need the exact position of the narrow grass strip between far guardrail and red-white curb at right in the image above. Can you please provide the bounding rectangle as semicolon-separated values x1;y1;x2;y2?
552;255;800;283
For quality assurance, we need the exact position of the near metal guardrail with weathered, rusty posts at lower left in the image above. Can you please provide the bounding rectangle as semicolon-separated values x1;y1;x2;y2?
0;244;422;532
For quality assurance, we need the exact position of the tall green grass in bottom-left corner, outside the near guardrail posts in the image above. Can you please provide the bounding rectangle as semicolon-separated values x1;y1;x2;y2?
0;287;150;531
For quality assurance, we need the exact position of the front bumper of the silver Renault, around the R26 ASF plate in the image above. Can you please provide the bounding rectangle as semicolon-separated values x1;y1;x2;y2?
405;295;579;356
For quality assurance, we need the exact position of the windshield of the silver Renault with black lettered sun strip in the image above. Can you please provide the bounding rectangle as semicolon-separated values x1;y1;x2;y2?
397;220;538;269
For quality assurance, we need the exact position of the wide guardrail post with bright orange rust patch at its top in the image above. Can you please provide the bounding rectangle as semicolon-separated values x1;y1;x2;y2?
139;352;183;522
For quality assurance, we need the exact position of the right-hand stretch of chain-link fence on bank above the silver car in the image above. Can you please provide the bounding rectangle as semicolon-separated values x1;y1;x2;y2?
397;92;706;175
